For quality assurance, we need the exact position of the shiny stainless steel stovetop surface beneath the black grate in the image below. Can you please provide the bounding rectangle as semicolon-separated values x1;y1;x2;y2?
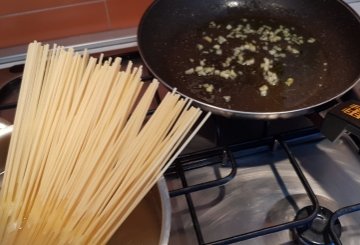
167;131;360;245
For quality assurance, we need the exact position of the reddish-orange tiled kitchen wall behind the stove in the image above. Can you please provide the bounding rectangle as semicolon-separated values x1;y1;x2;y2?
0;0;153;48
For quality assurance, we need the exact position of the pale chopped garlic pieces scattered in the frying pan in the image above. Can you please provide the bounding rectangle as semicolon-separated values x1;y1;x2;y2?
185;19;318;97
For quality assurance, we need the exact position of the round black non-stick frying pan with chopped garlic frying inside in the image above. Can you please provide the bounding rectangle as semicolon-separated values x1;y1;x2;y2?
138;0;360;119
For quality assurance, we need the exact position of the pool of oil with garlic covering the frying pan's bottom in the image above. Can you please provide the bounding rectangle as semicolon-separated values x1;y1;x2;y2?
168;17;330;111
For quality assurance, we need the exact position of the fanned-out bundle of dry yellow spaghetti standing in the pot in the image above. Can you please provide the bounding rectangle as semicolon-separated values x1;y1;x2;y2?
0;42;208;244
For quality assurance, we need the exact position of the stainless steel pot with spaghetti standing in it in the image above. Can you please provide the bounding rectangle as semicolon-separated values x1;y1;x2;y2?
0;122;171;245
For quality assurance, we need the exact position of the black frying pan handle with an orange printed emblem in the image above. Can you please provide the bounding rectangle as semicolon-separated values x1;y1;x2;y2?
321;100;360;141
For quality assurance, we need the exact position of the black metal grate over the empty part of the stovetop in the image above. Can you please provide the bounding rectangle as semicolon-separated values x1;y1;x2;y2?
165;128;360;245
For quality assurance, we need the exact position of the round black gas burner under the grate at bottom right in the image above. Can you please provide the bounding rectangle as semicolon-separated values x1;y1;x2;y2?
292;206;341;245
